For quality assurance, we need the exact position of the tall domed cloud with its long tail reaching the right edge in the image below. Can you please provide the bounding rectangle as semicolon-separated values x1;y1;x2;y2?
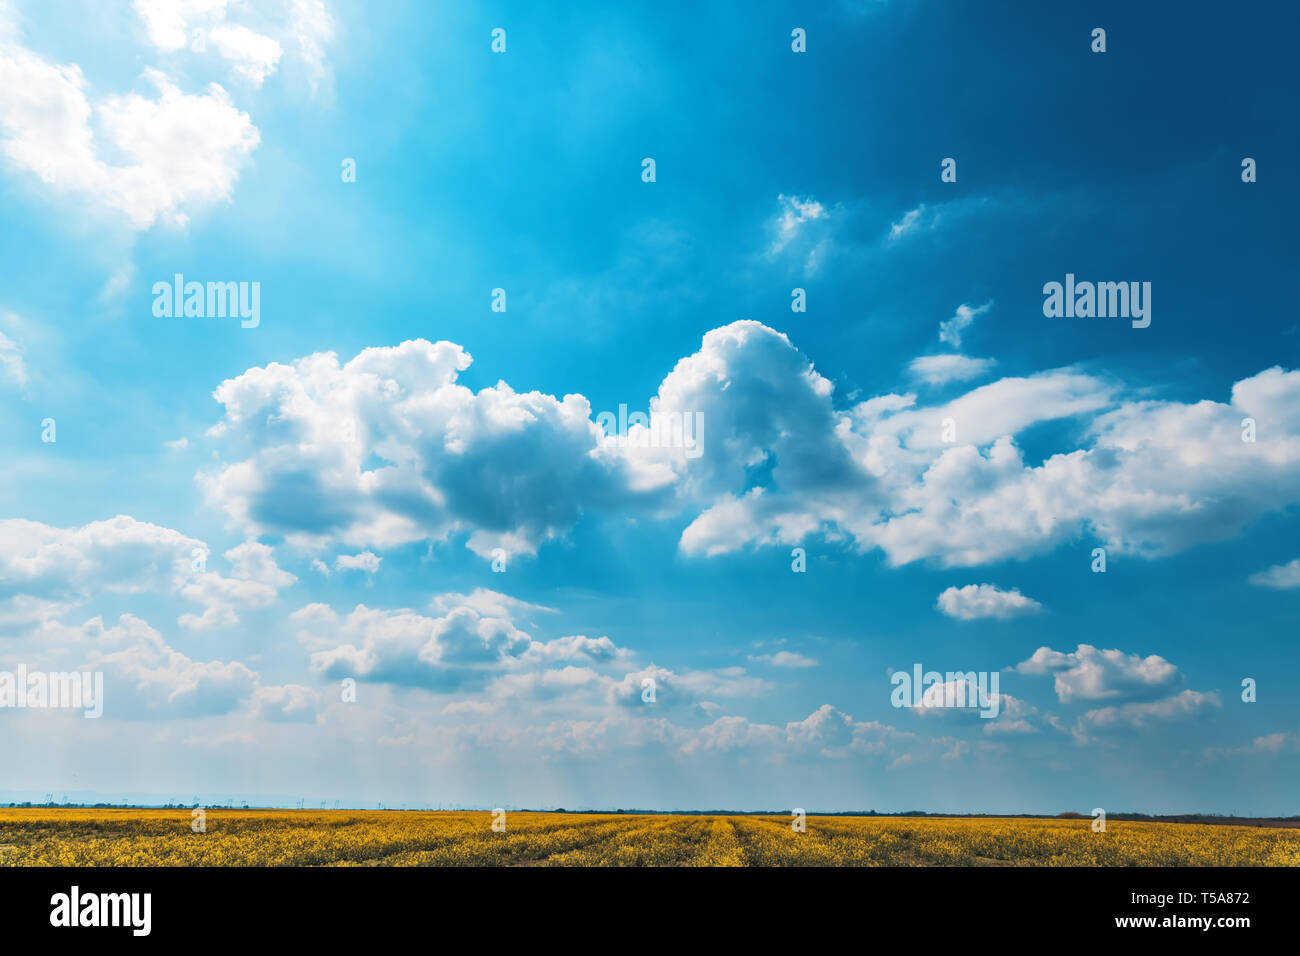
658;323;1300;567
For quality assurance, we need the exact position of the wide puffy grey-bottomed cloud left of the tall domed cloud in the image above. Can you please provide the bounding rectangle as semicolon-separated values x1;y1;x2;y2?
200;339;660;557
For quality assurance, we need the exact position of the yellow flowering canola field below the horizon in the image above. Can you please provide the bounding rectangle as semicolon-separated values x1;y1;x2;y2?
0;808;1300;866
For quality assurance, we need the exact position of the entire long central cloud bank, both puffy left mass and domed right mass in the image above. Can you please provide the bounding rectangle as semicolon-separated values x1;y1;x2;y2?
200;321;1300;567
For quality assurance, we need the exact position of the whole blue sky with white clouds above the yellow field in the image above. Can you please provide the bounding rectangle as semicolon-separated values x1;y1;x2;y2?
0;0;1300;814
